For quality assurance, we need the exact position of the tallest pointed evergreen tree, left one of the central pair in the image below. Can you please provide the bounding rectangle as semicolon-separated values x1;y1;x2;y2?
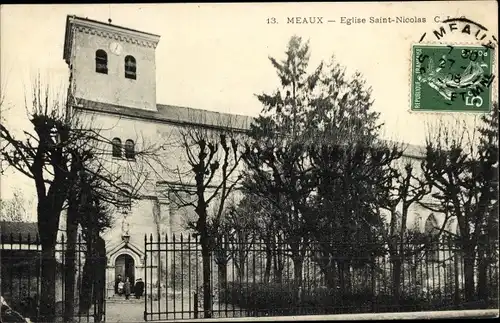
244;36;322;292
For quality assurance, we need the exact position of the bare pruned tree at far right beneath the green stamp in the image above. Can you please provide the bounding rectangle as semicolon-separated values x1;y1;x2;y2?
422;106;498;302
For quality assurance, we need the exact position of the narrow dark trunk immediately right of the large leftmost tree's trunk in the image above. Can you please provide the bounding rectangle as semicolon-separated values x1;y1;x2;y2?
64;207;78;322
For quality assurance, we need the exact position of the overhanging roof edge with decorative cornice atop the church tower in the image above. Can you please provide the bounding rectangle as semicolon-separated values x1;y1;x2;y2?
63;15;160;64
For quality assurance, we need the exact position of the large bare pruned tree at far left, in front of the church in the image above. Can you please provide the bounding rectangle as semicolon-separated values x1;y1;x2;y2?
0;79;156;321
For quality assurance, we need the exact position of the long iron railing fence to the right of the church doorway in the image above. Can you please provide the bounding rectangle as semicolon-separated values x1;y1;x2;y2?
144;235;498;321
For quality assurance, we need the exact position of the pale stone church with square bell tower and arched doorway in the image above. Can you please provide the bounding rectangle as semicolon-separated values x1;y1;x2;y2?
63;16;452;294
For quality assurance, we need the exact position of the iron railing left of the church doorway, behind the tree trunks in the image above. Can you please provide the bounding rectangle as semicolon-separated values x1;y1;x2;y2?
0;234;105;322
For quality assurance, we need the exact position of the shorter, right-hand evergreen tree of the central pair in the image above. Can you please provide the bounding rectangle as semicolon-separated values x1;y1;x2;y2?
307;56;388;291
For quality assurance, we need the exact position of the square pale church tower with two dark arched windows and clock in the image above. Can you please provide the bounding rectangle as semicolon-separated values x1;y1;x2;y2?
63;16;160;111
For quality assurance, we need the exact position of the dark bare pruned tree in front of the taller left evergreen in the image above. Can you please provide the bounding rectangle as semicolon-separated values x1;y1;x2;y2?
244;141;314;290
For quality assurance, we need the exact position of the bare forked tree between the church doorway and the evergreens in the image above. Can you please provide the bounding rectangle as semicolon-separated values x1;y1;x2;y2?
155;116;242;318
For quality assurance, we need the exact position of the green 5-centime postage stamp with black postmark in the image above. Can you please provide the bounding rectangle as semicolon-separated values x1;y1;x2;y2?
410;45;495;112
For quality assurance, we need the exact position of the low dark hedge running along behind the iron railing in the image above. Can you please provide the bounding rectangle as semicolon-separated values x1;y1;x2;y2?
220;282;468;315
